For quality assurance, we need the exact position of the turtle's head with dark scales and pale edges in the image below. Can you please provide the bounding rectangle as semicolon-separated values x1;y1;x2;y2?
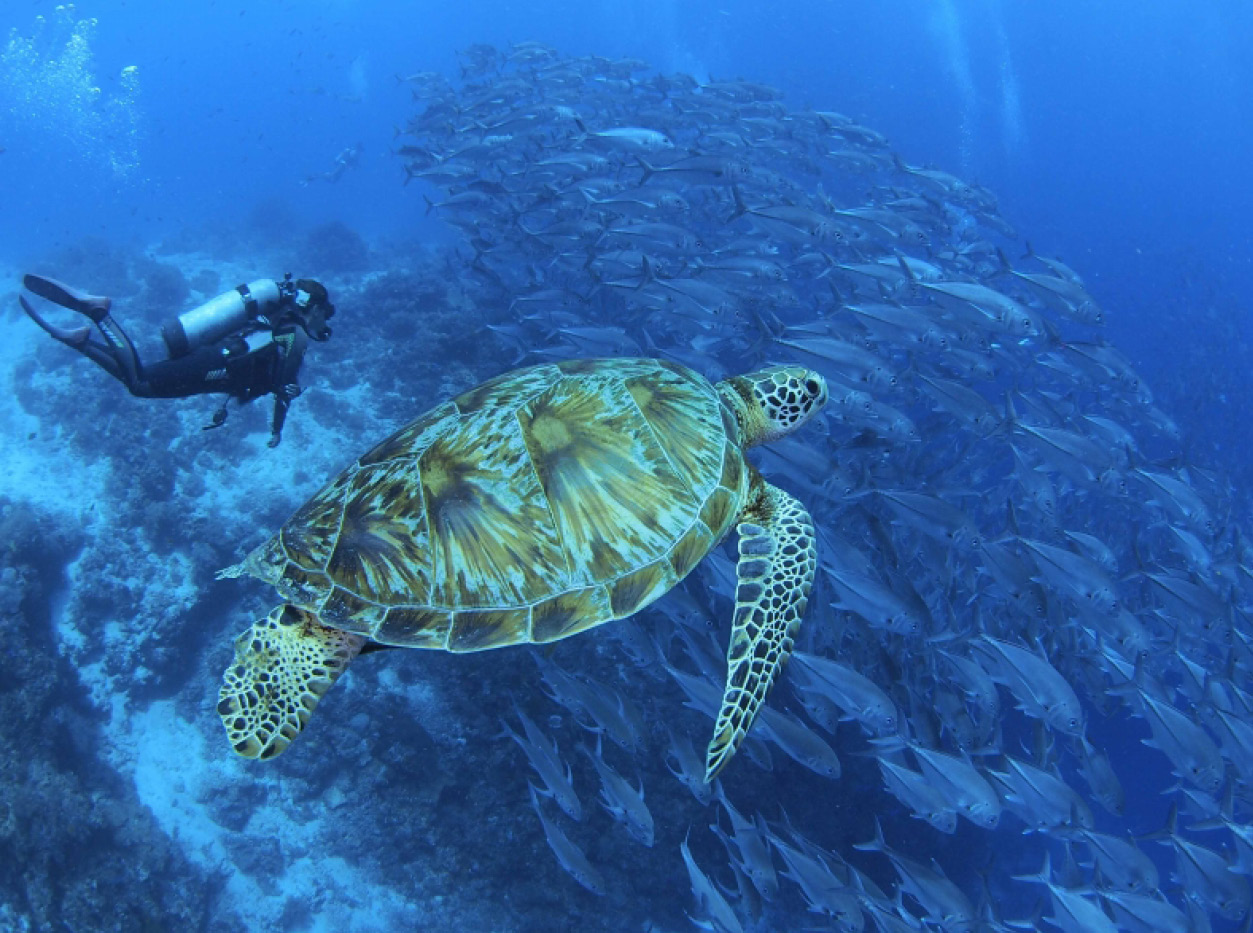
720;363;827;447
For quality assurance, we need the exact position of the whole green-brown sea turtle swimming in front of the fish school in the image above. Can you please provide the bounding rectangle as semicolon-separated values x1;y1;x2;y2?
218;358;827;780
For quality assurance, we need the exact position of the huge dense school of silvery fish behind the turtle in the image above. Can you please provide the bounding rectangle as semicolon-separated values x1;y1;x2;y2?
395;44;1253;933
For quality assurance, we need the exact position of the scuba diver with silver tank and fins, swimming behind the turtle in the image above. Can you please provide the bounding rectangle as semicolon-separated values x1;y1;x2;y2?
18;273;335;447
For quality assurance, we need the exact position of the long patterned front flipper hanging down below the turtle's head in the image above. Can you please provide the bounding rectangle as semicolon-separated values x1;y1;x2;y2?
705;477;818;783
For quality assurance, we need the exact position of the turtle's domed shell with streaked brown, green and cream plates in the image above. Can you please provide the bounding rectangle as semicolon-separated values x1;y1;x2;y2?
246;359;749;651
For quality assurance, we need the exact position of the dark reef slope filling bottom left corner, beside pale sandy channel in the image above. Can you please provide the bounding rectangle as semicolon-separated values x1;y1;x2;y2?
0;500;243;933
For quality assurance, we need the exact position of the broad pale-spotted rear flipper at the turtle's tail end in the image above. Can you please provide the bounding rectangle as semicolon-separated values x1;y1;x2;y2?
218;605;366;759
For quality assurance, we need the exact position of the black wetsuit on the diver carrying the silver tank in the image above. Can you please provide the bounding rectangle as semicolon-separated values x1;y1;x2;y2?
75;305;308;437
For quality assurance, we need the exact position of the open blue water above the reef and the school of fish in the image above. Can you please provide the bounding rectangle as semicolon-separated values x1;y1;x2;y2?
0;0;1253;930
